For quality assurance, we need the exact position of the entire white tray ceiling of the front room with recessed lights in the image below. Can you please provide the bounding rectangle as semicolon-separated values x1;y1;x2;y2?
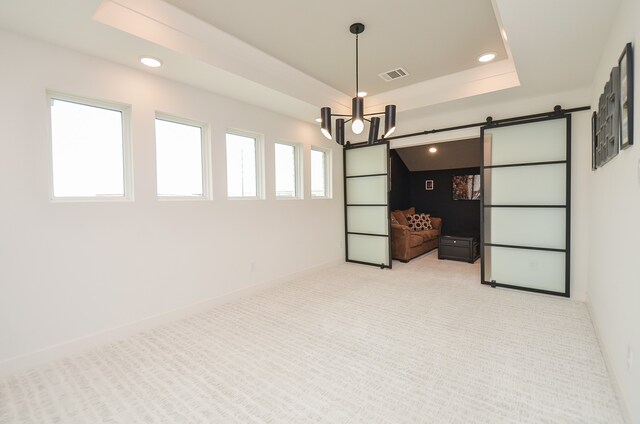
0;0;619;126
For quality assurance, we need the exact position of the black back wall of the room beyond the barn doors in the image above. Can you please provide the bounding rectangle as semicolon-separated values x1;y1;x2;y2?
408;168;480;236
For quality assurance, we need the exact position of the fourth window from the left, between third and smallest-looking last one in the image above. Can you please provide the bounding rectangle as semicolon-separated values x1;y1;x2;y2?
275;143;302;199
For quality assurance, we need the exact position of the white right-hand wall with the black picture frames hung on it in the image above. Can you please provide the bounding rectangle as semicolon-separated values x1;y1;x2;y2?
587;0;640;423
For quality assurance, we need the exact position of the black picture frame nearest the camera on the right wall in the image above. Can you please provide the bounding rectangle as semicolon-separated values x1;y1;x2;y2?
618;43;633;150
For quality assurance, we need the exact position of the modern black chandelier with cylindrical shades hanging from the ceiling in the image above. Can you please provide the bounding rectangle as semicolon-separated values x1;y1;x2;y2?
320;23;396;146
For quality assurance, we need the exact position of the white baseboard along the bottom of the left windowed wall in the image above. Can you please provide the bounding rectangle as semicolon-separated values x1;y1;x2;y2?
0;259;344;378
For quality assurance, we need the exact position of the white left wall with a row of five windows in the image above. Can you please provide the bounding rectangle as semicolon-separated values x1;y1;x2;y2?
0;32;344;370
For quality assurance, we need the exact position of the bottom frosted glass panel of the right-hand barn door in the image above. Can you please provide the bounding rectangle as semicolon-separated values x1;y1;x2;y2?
485;247;565;293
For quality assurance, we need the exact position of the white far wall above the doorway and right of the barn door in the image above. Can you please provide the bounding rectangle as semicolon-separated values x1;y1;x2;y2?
392;89;591;301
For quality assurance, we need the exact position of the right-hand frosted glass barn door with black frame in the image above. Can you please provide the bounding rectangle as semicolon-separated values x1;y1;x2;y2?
481;115;571;296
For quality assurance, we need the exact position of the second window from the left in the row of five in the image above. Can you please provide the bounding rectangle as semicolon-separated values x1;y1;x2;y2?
156;115;209;198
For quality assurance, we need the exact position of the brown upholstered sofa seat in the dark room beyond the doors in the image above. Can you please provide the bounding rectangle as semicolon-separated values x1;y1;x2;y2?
391;208;442;262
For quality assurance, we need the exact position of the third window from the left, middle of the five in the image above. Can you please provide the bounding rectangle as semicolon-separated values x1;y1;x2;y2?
227;132;263;198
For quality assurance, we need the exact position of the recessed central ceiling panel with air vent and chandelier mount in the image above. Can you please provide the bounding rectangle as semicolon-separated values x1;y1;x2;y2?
166;0;507;96
